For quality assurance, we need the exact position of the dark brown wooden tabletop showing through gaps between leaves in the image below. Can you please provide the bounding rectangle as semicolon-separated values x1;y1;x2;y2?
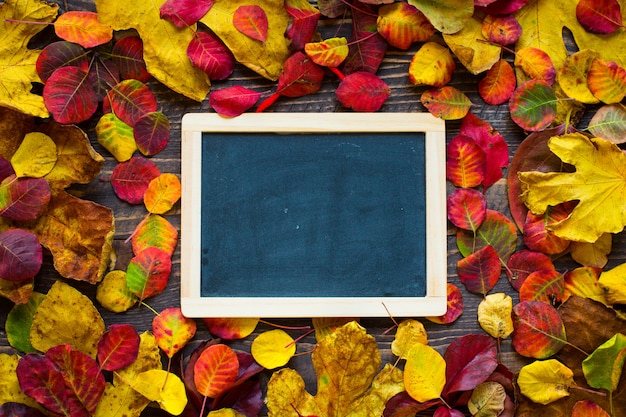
0;0;626;415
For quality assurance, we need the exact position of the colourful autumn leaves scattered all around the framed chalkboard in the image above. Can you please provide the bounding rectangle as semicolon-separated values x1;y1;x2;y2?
0;0;626;417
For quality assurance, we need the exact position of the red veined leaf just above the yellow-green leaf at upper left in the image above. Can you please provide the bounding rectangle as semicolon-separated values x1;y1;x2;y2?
107;80;157;126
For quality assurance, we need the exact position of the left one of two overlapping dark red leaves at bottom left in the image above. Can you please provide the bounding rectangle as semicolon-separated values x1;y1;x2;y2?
16;353;70;415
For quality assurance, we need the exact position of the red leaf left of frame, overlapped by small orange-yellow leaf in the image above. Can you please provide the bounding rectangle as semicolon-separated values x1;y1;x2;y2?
111;156;161;204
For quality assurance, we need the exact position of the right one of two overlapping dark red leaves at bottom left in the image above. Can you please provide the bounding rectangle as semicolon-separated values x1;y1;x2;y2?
45;345;105;416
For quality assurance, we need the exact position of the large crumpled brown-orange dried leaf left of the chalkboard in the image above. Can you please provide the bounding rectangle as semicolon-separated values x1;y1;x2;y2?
29;191;115;284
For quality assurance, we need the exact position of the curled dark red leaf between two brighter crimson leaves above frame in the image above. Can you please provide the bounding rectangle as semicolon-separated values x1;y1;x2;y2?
276;52;324;97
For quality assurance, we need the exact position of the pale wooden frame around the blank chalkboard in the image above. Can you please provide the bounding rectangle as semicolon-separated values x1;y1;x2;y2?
181;113;447;317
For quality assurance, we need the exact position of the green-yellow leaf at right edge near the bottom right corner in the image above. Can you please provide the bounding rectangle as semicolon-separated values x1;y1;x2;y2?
582;333;626;392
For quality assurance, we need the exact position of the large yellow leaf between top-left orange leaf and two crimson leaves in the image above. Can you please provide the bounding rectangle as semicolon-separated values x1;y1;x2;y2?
96;0;208;101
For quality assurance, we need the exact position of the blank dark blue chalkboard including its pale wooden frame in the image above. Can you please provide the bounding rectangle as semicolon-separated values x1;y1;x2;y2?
181;113;446;317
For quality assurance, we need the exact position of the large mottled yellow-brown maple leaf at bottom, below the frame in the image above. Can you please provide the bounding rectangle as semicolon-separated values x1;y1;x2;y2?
267;321;404;417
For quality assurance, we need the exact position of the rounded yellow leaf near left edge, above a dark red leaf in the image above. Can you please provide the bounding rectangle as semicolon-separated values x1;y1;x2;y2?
11;132;57;178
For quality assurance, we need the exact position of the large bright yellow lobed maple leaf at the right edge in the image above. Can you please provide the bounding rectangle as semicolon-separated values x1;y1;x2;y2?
519;133;626;242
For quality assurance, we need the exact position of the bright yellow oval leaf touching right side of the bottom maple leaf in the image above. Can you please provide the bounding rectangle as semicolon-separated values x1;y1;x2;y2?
404;344;446;403
